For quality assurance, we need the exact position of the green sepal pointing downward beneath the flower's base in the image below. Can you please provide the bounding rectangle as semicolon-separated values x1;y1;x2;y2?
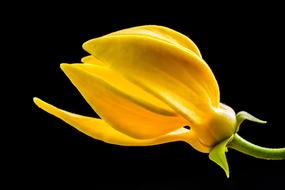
209;135;234;178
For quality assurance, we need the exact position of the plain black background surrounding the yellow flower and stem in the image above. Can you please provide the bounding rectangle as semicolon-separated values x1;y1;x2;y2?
4;2;285;189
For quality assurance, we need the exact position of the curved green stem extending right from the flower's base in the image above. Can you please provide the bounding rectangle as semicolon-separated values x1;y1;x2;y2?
227;134;285;160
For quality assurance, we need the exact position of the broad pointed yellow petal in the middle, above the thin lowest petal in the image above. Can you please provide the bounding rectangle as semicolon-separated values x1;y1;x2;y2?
61;64;188;139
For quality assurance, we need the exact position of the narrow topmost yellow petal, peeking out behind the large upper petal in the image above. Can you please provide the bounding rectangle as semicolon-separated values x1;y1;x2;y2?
109;25;202;57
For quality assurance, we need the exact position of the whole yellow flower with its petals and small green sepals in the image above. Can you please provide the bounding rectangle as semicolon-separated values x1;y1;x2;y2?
34;25;284;177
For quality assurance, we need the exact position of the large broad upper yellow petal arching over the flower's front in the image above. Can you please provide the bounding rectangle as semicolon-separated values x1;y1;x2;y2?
83;35;219;123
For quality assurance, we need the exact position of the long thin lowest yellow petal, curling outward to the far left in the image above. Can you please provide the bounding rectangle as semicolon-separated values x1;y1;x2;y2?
34;98;209;152
